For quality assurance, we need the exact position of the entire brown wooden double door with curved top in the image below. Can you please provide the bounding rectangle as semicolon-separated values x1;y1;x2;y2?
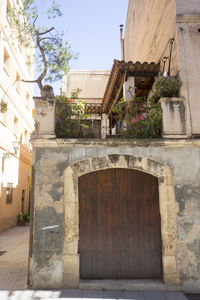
79;169;162;279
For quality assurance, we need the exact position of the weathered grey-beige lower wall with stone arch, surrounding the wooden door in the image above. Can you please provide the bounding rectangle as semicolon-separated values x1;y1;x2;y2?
29;139;200;291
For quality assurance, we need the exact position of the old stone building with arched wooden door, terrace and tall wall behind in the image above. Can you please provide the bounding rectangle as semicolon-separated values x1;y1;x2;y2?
29;0;200;291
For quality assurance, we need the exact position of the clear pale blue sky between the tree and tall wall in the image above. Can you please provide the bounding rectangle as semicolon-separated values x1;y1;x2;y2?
35;0;128;92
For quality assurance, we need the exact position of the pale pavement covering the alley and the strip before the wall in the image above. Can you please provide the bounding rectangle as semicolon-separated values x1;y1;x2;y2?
0;226;197;300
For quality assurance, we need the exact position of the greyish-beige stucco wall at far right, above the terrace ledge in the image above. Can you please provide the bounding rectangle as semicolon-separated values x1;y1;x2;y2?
175;0;200;136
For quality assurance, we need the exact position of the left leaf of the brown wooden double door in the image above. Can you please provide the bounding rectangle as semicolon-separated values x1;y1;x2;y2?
79;169;119;279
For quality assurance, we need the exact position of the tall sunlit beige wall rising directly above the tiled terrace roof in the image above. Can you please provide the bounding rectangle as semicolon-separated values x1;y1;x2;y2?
124;0;178;74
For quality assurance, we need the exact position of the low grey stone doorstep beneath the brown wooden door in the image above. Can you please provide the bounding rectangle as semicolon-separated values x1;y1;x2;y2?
79;279;180;292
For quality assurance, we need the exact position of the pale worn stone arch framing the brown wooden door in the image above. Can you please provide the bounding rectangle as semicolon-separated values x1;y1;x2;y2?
63;154;179;287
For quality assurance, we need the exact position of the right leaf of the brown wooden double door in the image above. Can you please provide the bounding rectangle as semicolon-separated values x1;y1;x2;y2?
117;169;162;279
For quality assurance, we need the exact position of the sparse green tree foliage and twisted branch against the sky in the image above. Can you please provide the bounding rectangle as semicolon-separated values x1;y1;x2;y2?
9;0;75;91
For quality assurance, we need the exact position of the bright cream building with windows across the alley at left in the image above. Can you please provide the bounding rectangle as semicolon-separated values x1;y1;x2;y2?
0;0;34;232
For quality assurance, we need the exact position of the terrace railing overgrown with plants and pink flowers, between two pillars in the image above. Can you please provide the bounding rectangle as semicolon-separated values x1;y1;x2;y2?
56;101;162;139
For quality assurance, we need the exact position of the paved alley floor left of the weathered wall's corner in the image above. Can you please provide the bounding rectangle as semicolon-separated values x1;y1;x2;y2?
0;226;29;290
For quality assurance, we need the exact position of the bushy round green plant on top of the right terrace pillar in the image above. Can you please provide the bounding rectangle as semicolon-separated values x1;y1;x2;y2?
150;76;182;103
